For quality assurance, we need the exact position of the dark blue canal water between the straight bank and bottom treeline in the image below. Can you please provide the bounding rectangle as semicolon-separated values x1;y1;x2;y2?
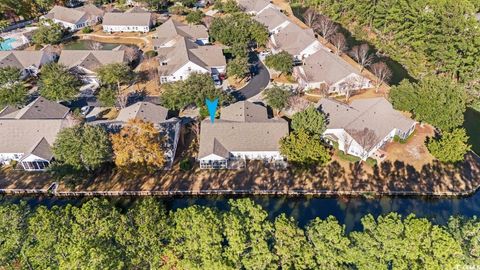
0;192;480;231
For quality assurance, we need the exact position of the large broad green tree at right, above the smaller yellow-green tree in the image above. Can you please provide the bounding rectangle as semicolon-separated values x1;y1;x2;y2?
390;76;466;131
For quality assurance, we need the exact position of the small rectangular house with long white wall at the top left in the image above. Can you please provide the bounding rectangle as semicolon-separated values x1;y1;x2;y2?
102;12;153;33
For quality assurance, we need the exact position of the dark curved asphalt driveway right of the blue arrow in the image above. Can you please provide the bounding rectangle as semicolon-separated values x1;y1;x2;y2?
232;52;270;101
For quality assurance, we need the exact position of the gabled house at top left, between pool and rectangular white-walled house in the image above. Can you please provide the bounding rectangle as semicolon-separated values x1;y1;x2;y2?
43;4;104;31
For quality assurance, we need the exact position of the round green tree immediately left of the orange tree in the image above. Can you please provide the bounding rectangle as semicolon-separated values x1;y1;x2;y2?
52;125;112;171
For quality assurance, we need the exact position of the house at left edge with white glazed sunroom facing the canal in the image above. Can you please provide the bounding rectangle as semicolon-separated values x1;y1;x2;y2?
0;97;71;171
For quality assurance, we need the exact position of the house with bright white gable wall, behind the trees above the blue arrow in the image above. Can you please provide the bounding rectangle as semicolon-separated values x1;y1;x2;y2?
157;37;227;83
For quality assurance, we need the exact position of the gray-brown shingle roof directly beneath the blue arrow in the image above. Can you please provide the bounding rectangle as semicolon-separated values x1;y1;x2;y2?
198;101;288;158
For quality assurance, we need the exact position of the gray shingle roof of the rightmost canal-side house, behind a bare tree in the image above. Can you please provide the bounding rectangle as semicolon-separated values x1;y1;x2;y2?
318;97;415;146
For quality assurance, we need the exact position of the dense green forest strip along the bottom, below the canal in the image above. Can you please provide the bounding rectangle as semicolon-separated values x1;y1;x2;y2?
0;198;480;269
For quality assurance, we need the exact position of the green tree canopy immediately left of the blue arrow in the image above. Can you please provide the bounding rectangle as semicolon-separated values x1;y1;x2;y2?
161;73;233;110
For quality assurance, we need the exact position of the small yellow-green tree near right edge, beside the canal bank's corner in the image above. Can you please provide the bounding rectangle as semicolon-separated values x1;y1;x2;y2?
427;128;472;163
